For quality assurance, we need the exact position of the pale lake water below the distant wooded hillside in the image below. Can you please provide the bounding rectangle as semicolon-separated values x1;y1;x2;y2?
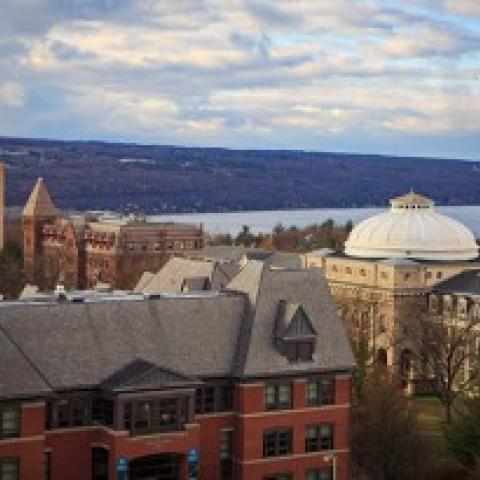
150;205;480;237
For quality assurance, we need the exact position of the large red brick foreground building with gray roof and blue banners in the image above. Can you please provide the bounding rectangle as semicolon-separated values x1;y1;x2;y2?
0;262;353;480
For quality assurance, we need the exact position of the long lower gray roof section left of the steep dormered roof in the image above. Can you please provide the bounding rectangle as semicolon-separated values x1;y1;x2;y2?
0;295;245;397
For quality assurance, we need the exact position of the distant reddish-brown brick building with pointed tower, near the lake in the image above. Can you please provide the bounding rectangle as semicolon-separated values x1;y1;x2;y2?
22;178;204;289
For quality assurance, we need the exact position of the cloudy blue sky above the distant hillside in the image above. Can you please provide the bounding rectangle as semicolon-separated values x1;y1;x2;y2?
0;0;480;159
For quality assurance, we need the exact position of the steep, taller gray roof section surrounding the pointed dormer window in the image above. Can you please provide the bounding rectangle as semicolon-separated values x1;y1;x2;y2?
228;261;355;377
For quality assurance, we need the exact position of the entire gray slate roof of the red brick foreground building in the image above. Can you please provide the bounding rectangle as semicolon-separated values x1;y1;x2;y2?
0;261;354;399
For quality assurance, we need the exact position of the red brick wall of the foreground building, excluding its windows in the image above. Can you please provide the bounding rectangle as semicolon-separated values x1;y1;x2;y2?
0;377;350;480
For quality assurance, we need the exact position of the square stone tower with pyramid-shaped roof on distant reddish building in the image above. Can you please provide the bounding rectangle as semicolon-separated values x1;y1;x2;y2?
22;178;57;284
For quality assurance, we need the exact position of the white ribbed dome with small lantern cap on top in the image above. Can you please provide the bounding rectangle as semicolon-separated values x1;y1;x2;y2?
345;192;478;260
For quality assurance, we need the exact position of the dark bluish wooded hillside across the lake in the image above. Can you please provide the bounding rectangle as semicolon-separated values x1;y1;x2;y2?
0;138;480;213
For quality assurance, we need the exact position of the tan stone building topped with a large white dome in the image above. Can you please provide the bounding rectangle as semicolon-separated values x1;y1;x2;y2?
305;192;480;382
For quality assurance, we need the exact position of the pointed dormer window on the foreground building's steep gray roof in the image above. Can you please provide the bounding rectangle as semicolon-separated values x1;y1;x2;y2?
275;300;317;363
